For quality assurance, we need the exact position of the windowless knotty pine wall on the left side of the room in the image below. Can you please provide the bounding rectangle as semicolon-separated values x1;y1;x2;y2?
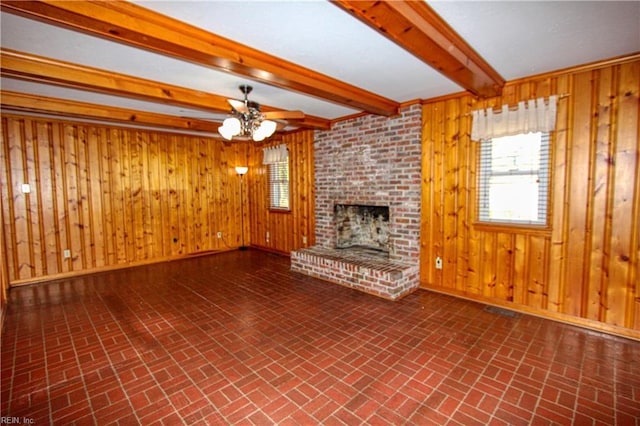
0;115;250;284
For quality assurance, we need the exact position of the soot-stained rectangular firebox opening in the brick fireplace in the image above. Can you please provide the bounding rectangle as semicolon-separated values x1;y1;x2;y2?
334;204;390;253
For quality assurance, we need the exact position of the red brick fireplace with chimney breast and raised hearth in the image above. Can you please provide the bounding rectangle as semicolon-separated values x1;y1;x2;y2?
291;105;422;300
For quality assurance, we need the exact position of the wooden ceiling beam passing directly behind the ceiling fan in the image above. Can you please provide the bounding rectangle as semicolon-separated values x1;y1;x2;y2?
0;48;331;130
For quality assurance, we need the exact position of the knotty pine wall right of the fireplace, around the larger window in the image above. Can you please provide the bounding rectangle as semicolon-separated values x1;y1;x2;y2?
421;57;640;337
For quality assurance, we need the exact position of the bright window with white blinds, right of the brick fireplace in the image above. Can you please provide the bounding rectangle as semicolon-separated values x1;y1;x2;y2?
478;132;550;226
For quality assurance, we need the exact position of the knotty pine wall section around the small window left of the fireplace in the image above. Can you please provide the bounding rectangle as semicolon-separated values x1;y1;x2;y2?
248;130;315;254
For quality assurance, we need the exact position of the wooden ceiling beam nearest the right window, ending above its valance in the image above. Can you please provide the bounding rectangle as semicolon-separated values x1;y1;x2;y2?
332;0;505;98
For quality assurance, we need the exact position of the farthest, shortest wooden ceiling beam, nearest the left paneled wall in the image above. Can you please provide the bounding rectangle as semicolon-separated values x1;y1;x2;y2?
0;91;222;133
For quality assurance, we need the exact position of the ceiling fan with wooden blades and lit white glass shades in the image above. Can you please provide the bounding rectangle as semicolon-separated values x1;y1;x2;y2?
218;84;304;142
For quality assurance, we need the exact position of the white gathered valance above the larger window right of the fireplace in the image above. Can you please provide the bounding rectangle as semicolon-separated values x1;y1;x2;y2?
471;96;557;141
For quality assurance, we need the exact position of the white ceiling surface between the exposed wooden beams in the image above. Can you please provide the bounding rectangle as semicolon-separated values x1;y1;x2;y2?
1;0;640;133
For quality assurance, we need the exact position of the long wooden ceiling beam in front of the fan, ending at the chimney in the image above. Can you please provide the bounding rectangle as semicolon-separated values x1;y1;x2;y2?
0;0;399;116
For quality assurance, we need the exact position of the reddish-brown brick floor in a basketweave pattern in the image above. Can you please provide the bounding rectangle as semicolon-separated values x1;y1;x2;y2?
0;250;640;425
